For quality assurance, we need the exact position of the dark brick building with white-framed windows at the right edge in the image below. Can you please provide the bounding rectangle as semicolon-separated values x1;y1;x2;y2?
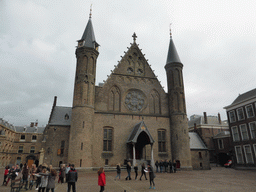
224;89;256;168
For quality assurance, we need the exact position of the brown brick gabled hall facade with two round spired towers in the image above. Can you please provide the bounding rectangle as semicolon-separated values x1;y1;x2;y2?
68;12;192;169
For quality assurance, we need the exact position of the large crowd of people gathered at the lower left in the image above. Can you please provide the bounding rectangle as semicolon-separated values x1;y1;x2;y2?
3;163;78;192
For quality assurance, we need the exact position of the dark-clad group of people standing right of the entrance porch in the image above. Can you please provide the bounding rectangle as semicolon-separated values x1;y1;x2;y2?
155;160;177;173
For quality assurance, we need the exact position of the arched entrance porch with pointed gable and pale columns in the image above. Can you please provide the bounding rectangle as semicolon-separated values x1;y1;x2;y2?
127;121;154;165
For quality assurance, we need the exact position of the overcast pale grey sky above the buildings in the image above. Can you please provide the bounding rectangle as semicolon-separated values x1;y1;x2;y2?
0;0;256;126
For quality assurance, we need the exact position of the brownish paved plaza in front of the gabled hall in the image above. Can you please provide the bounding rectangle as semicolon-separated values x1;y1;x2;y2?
0;167;256;192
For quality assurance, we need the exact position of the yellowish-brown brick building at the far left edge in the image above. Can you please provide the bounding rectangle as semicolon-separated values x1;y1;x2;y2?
0;119;44;167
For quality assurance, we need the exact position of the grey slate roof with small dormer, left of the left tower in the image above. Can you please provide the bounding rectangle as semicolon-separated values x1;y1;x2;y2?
49;106;72;126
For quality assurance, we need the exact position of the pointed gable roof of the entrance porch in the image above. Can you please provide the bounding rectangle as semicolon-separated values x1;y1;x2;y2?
127;121;155;143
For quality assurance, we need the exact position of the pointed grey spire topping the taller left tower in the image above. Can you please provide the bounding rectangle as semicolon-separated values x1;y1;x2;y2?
78;6;99;49
